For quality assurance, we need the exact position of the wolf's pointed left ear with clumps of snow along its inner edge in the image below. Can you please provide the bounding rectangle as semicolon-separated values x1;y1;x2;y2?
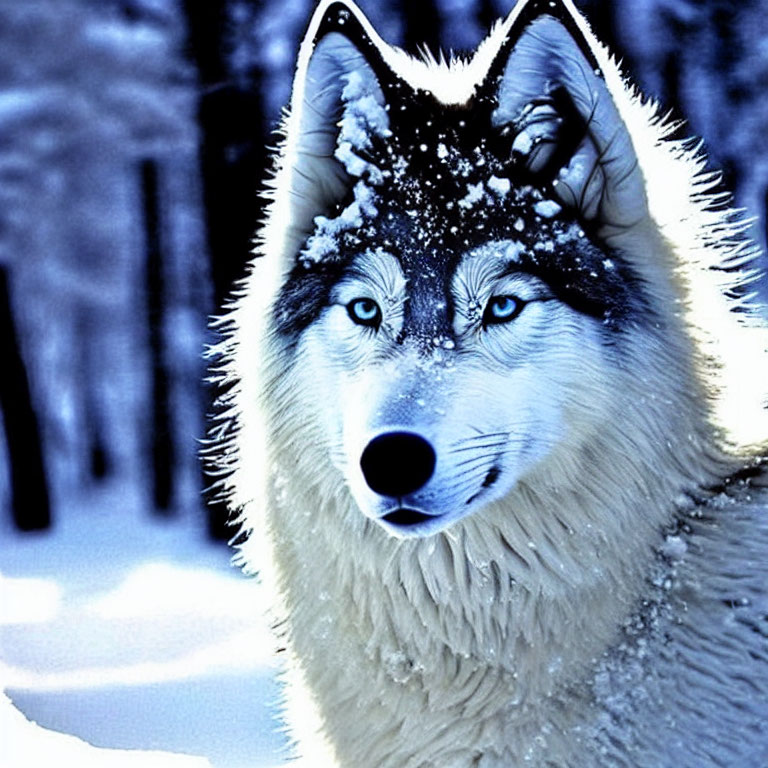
278;0;391;256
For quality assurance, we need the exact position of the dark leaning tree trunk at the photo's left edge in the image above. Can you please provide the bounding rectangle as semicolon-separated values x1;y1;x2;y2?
0;266;51;531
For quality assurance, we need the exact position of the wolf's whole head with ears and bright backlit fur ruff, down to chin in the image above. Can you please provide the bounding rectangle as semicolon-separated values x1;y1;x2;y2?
216;0;768;548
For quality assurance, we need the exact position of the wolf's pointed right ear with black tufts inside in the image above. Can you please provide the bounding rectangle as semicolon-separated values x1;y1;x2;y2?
486;0;648;245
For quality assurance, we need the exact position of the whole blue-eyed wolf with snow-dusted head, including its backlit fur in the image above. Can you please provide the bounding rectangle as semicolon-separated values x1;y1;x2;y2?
214;0;768;768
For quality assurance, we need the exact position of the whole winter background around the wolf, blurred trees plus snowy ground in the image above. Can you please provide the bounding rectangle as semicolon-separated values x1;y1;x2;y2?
0;0;768;768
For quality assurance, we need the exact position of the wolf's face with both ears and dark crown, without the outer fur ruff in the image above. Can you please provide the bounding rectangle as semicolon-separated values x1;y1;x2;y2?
272;3;664;537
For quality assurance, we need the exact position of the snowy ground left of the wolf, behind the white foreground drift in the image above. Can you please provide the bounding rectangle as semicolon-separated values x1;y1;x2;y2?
0;484;292;768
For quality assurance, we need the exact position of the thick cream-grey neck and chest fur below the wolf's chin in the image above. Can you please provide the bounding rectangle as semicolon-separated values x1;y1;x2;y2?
234;320;725;768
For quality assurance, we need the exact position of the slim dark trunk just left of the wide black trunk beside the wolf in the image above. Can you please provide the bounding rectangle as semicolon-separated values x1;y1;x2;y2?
141;160;175;513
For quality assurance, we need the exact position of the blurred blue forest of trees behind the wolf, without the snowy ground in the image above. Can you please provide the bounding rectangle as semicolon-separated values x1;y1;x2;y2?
0;0;768;538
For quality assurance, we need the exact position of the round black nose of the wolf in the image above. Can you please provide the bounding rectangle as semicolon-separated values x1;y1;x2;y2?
360;432;436;497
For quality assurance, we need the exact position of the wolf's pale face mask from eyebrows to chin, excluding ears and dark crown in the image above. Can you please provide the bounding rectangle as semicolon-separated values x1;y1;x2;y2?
302;240;603;536
